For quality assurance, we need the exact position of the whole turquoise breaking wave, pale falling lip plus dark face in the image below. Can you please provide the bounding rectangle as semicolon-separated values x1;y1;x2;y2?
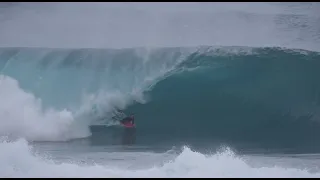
0;47;320;144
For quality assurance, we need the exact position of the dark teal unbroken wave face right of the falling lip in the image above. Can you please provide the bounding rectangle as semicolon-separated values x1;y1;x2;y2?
125;48;320;144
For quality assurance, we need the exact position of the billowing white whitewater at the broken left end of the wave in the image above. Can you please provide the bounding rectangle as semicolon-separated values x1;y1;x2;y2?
0;75;90;141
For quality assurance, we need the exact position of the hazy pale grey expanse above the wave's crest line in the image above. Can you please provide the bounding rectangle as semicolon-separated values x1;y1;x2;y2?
0;2;320;51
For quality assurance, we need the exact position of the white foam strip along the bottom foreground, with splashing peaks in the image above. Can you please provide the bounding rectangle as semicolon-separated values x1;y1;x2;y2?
0;139;320;178
